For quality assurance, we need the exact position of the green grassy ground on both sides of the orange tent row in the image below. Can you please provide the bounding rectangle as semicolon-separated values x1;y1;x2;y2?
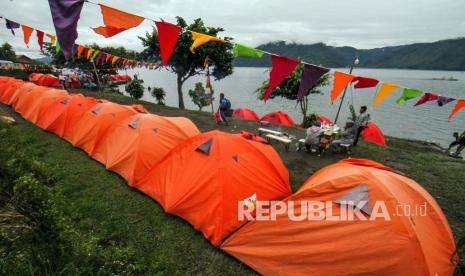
0;89;465;275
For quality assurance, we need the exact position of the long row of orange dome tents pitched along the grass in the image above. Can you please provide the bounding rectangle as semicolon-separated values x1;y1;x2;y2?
0;77;458;275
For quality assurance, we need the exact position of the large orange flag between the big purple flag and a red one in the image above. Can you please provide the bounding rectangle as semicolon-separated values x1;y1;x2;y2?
92;4;144;37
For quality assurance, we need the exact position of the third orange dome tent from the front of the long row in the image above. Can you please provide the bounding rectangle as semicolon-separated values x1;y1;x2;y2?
92;114;200;186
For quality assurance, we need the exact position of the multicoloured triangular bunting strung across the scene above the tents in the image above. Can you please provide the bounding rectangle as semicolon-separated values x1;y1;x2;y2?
6;0;465;121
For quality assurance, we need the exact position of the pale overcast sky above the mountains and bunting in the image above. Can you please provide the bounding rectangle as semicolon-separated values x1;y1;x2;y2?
0;0;465;57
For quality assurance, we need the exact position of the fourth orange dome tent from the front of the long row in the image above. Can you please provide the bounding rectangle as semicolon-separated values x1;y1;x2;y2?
64;102;137;154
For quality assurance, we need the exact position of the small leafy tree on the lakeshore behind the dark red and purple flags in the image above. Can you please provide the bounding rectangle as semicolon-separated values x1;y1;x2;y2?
255;63;330;124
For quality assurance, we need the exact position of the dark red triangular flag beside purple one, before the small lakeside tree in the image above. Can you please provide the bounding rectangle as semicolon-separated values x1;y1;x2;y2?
263;55;300;102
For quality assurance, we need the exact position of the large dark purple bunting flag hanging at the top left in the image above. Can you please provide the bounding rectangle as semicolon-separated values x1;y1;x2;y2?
48;0;84;61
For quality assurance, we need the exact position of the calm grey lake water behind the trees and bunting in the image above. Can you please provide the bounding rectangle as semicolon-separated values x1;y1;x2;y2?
121;67;465;146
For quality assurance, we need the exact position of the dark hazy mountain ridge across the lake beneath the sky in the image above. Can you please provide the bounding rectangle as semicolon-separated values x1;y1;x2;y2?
235;38;465;71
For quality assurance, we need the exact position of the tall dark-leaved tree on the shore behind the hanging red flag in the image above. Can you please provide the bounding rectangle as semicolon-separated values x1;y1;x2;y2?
139;17;233;109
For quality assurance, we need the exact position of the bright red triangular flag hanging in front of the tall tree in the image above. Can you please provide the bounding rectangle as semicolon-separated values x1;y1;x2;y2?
155;21;182;65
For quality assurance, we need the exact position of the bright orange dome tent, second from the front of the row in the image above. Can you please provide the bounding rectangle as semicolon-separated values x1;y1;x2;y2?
136;131;291;245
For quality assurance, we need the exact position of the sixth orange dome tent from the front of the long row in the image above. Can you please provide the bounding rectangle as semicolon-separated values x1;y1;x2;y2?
23;89;68;124
